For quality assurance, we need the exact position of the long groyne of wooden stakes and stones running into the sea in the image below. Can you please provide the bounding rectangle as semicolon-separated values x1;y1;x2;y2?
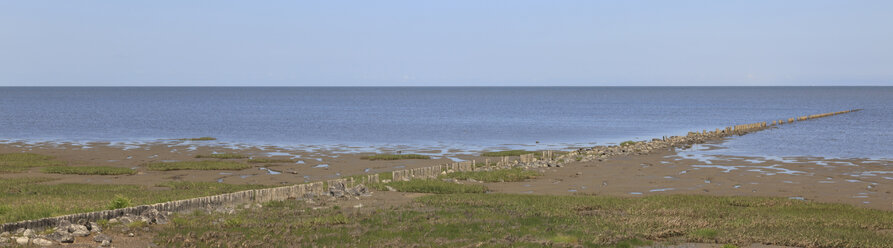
0;109;860;232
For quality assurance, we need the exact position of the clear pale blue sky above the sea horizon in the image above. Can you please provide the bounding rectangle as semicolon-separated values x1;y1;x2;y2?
0;0;893;86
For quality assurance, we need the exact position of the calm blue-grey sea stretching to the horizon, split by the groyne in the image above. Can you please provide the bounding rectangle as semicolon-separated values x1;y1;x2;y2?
0;87;893;158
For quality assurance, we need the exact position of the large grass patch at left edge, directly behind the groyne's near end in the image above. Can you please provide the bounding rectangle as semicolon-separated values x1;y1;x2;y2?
0;178;269;223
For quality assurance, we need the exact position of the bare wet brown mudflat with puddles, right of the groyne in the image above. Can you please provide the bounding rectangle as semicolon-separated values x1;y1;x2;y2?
487;144;893;210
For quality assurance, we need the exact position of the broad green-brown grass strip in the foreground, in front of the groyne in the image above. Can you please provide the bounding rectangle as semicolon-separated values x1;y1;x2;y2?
155;194;893;247
